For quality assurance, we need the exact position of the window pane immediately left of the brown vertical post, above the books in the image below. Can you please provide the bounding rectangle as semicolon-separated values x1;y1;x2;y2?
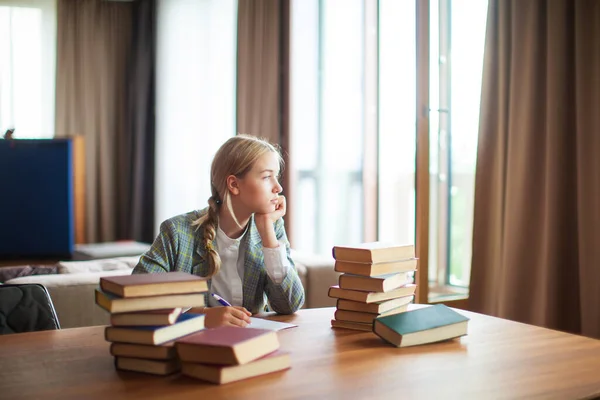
317;0;364;254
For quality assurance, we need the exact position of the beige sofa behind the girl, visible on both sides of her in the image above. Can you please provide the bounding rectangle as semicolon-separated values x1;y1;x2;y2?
0;250;339;328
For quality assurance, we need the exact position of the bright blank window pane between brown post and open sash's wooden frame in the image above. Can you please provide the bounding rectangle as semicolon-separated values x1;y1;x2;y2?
378;0;416;247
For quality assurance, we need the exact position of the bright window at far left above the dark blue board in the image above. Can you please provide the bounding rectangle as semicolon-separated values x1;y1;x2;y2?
0;0;56;139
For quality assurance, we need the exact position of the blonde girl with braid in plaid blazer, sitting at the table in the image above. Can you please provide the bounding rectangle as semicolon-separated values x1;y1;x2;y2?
133;135;304;328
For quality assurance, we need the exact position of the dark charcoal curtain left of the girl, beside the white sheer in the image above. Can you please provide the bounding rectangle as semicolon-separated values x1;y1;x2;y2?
117;0;156;243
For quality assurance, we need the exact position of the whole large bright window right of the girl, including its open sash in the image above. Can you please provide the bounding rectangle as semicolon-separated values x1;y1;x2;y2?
290;0;487;299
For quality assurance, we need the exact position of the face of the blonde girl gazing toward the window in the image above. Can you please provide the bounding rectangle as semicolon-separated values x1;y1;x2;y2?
233;152;283;214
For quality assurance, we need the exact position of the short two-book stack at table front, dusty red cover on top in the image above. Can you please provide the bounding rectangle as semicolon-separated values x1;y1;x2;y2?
176;327;291;384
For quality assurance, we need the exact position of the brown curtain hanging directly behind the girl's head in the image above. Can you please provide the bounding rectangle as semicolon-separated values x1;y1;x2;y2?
237;0;293;242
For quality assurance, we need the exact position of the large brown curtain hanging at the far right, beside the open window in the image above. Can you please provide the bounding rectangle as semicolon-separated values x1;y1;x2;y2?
469;0;600;337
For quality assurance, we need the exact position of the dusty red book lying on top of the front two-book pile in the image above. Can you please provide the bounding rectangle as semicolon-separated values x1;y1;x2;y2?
175;326;279;365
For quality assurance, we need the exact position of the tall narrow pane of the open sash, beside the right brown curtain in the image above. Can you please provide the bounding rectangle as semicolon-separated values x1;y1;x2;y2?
448;0;487;286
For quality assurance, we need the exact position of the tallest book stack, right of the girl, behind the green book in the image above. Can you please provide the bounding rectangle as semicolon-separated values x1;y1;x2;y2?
329;242;417;331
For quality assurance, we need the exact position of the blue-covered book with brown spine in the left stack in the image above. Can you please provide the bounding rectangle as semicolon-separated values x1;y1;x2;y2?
104;313;204;345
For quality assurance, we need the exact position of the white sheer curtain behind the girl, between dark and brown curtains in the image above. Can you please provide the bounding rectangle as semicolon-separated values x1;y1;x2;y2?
155;0;237;229
